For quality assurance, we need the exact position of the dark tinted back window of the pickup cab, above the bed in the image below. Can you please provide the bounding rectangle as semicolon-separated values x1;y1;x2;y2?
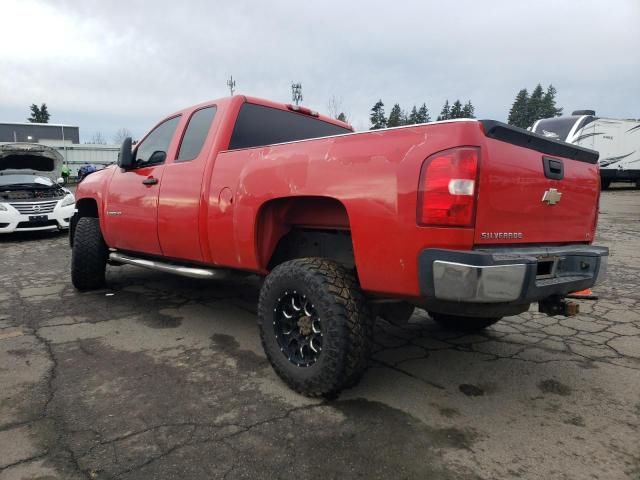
229;103;351;150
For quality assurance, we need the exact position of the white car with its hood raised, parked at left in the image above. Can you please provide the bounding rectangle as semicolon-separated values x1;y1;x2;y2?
0;143;76;233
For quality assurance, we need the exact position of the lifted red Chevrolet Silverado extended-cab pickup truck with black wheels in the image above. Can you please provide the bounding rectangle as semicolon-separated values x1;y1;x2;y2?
70;96;608;396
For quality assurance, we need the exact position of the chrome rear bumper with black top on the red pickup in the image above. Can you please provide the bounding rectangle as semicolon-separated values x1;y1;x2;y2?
418;245;609;305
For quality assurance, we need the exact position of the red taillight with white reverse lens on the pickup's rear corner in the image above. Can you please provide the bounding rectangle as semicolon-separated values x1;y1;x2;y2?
418;147;480;227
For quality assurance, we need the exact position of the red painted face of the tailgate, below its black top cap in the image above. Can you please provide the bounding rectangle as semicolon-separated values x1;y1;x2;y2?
475;139;600;244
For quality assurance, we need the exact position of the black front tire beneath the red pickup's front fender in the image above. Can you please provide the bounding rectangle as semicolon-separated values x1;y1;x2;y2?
71;217;109;290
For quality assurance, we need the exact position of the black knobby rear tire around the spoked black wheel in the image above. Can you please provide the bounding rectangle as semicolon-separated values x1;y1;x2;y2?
258;257;374;398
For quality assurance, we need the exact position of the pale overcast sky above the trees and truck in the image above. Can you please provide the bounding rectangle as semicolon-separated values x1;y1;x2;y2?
0;0;640;141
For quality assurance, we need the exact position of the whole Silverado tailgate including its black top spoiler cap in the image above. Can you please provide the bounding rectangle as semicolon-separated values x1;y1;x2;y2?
474;121;600;245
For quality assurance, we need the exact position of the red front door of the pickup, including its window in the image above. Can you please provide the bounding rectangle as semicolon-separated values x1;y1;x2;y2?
105;116;180;255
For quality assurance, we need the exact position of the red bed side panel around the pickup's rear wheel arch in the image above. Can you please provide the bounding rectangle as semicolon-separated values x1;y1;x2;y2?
209;122;480;296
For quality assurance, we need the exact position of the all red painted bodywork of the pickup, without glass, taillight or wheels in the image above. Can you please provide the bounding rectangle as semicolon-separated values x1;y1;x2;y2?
77;96;598;297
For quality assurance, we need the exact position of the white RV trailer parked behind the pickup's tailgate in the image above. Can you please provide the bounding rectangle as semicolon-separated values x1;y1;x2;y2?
532;110;640;190
